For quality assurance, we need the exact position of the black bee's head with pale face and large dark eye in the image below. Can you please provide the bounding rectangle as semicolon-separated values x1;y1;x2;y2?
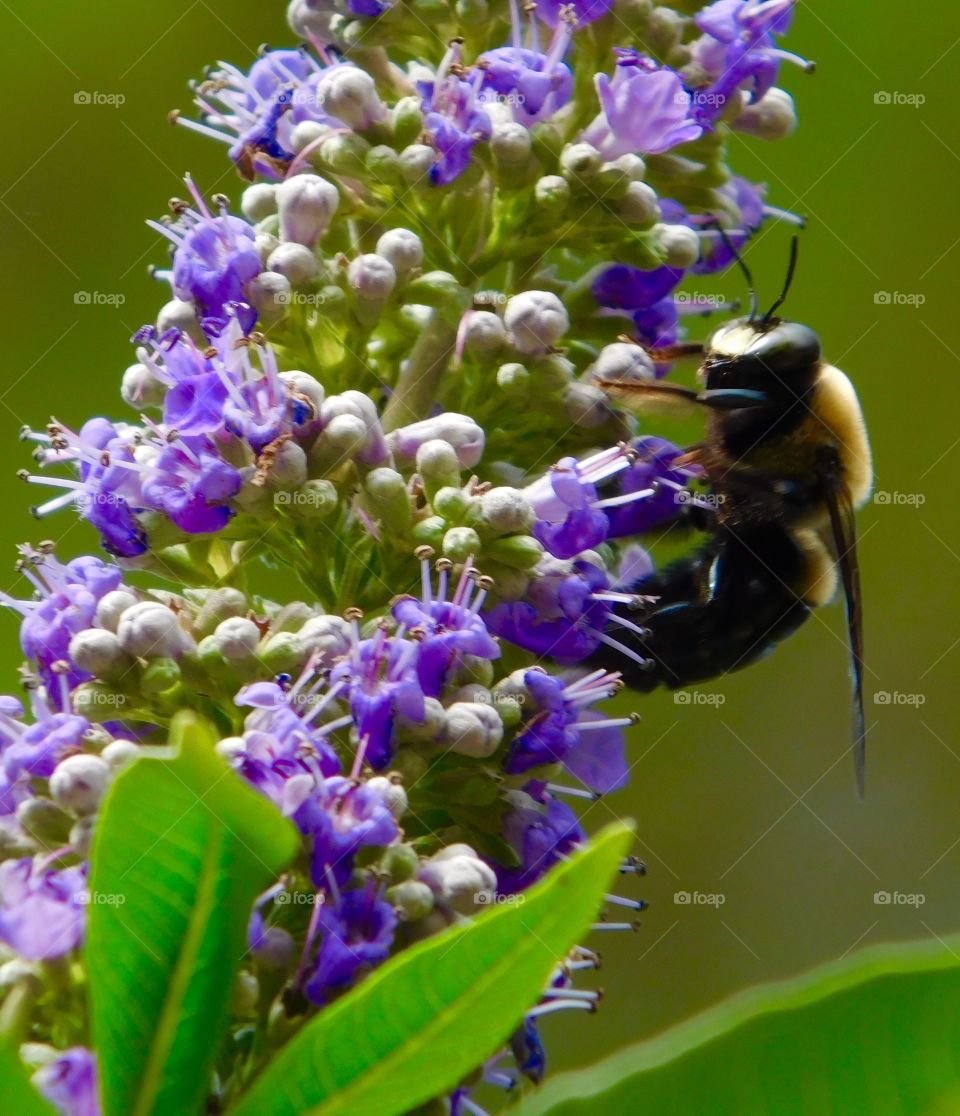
700;318;820;403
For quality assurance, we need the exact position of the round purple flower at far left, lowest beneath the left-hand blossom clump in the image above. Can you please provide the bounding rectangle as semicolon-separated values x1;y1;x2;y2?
143;437;242;535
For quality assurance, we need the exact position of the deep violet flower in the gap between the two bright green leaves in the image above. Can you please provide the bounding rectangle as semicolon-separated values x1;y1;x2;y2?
304;884;396;1003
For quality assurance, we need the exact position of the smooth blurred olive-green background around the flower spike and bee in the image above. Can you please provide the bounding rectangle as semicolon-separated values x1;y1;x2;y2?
0;0;960;1089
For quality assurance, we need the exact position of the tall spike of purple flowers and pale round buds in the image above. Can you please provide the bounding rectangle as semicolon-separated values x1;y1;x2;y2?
0;0;810;1116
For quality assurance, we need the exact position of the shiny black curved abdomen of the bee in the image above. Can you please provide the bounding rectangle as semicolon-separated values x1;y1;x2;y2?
587;523;812;692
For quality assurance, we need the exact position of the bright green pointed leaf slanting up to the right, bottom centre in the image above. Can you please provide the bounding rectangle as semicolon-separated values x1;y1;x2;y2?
231;826;631;1116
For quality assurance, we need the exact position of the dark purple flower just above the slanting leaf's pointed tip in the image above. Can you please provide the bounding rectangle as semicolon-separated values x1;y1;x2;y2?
497;785;586;894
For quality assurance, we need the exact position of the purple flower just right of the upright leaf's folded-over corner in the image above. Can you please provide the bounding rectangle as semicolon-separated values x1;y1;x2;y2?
294;776;397;887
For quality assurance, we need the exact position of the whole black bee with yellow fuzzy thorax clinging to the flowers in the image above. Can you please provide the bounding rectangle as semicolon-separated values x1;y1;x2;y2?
594;241;873;797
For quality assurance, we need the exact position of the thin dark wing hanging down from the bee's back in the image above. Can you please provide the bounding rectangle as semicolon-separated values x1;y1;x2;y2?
822;450;866;799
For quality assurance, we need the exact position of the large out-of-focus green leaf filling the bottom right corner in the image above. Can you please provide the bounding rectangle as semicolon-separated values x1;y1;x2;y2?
520;937;960;1116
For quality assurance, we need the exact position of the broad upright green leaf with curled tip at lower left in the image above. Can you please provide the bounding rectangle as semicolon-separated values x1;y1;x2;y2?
86;713;298;1116
